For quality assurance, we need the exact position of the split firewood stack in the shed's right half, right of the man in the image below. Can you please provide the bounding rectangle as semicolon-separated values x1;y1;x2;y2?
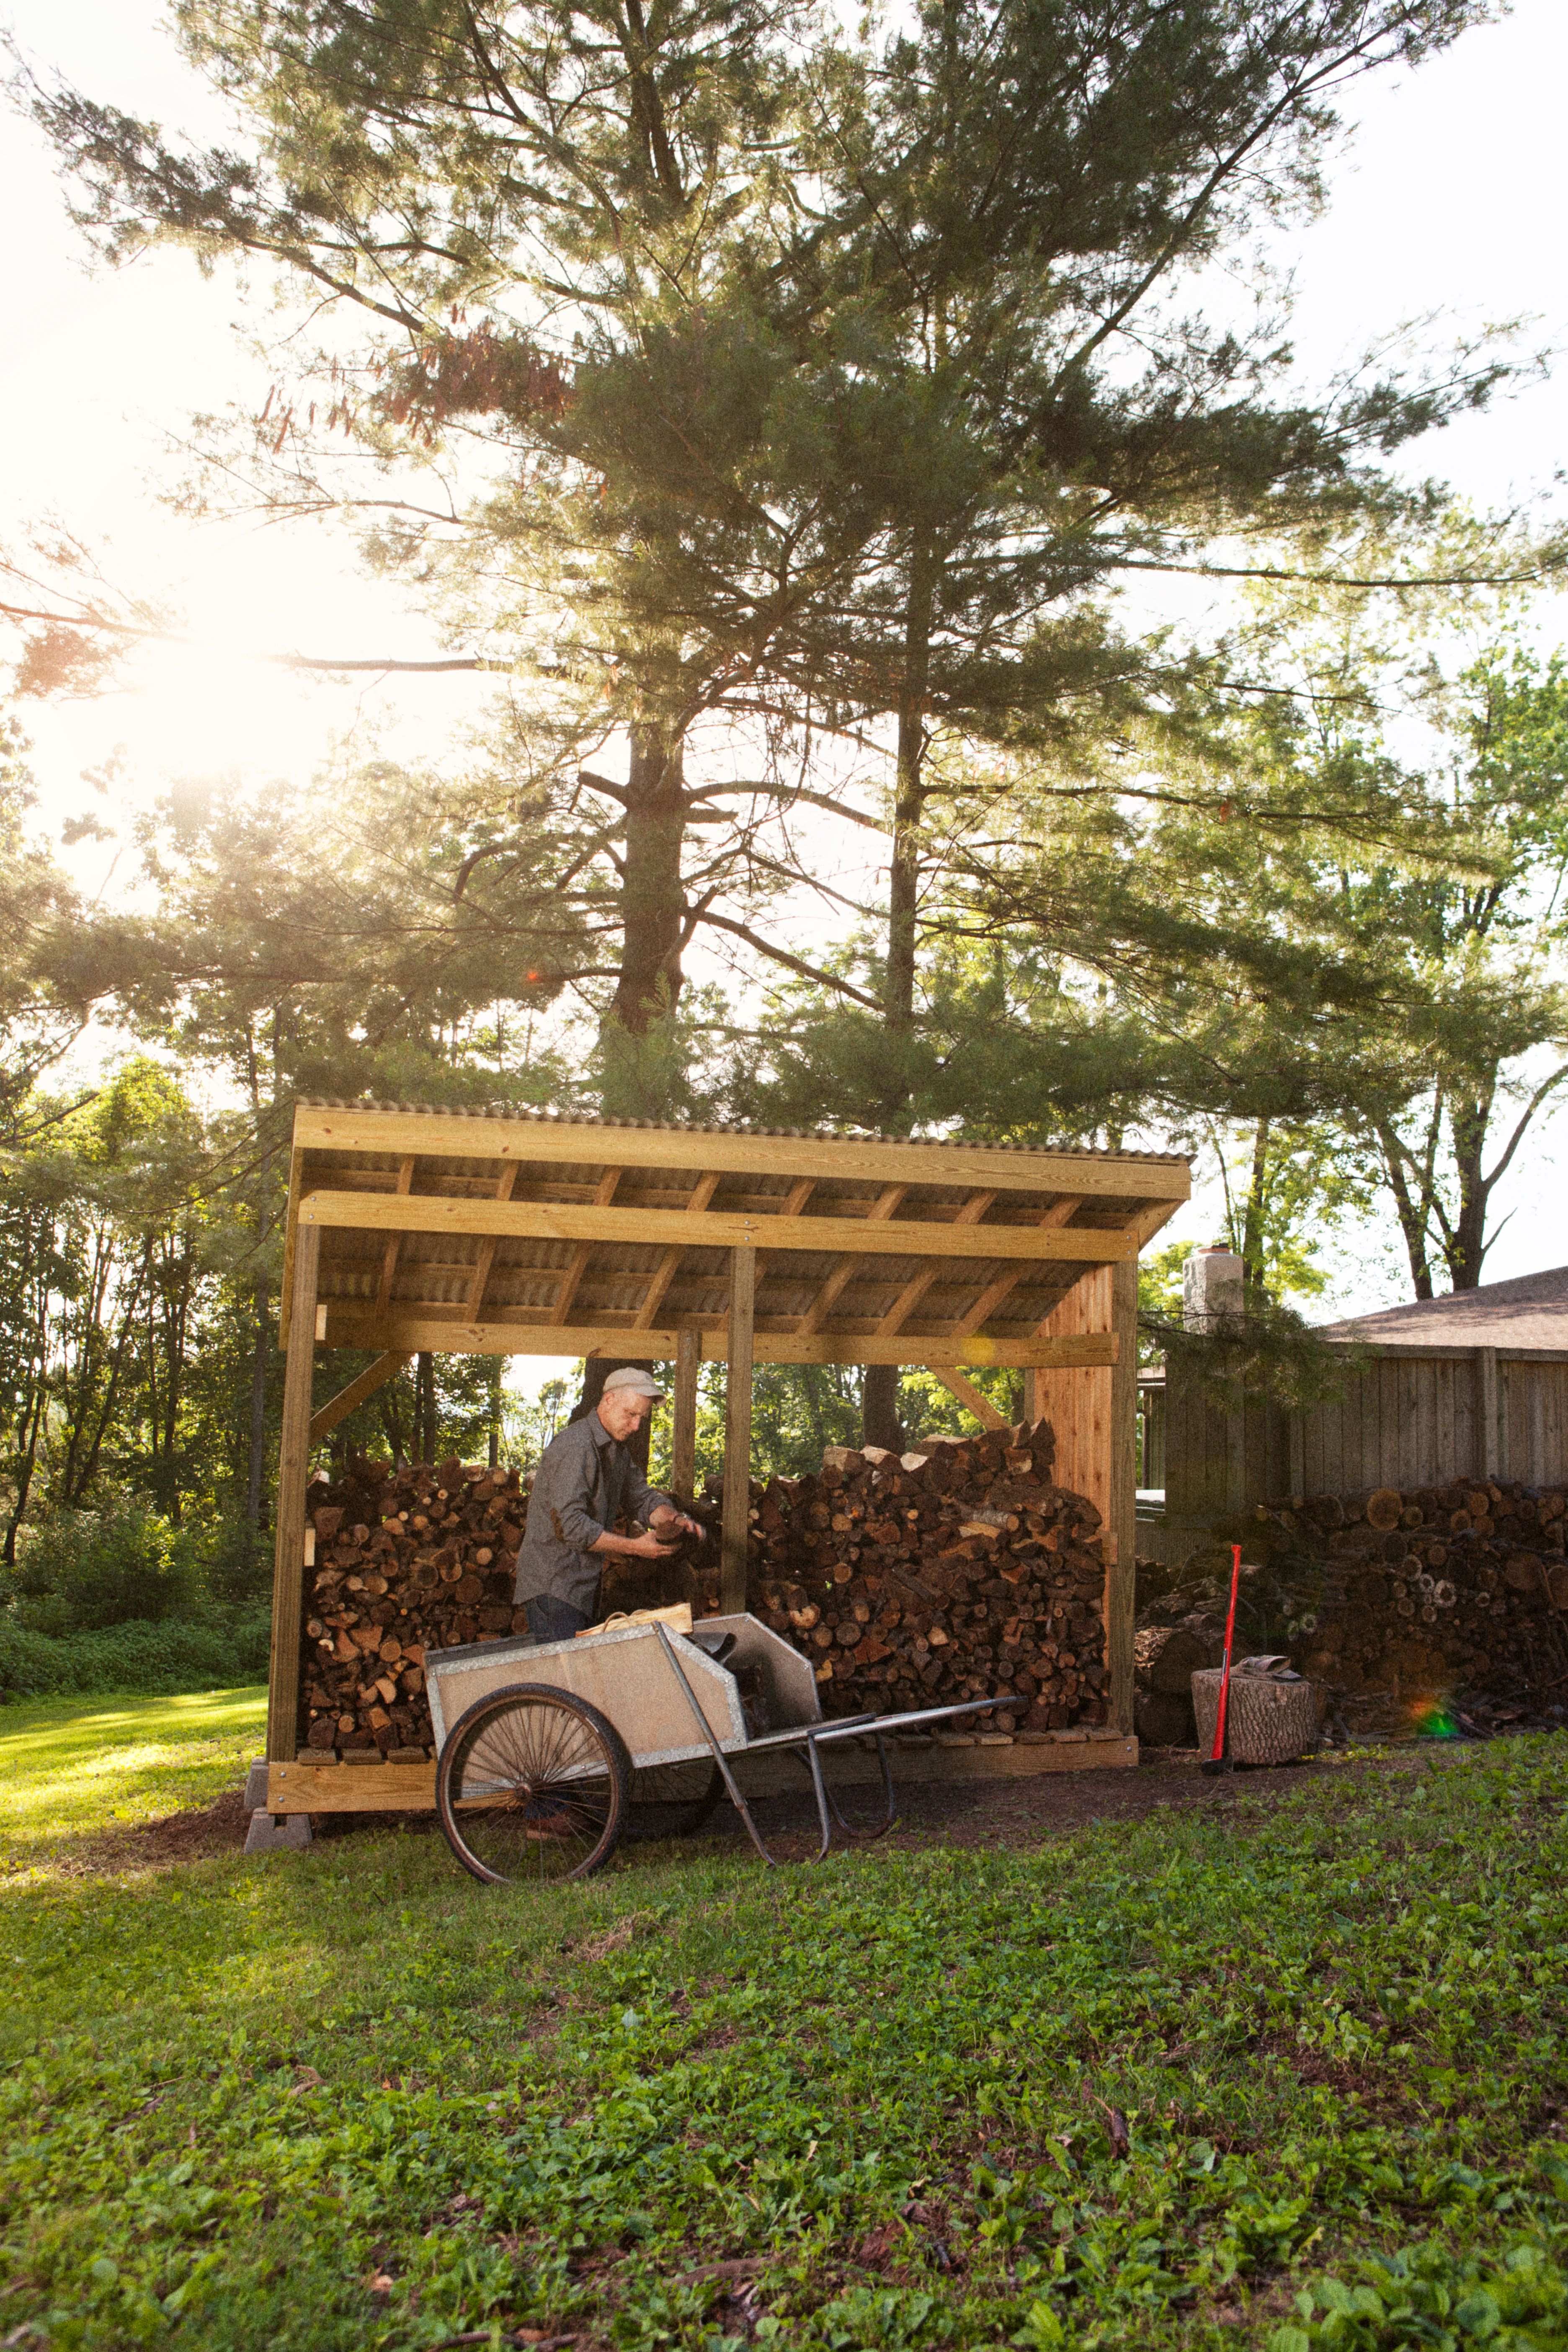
698;1421;1109;1731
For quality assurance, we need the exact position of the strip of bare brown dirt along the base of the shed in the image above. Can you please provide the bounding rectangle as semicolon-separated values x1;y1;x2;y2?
49;1743;1429;1877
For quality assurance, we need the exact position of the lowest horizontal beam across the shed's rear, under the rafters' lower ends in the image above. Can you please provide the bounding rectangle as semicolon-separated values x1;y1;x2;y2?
327;1301;1117;1369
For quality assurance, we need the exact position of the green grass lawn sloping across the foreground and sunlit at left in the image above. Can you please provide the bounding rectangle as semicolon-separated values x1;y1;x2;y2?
0;1694;1568;2352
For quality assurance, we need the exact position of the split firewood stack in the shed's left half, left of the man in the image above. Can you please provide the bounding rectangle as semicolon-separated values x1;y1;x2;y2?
299;1461;526;1755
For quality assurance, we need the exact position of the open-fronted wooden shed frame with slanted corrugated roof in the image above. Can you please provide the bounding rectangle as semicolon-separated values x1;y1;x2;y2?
266;1103;1189;1813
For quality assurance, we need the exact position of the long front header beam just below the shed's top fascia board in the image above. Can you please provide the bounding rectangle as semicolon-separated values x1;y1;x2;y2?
299;1185;1138;1279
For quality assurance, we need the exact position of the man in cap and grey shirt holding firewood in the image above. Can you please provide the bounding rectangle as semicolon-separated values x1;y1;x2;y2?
517;1364;703;1642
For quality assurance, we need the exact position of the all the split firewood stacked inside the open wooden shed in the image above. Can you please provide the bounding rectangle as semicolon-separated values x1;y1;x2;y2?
288;1421;1109;1755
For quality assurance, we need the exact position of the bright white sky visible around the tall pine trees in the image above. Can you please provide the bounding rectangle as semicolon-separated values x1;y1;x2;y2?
0;0;1568;1345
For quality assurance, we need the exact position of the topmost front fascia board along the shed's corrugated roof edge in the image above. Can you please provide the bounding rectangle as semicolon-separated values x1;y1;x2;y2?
294;1103;1192;1209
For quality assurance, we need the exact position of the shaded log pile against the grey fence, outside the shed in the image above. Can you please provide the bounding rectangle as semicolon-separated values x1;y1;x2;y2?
1135;1479;1568;1743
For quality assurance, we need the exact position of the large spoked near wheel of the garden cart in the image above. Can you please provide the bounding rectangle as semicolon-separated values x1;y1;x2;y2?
435;1681;632;1884
